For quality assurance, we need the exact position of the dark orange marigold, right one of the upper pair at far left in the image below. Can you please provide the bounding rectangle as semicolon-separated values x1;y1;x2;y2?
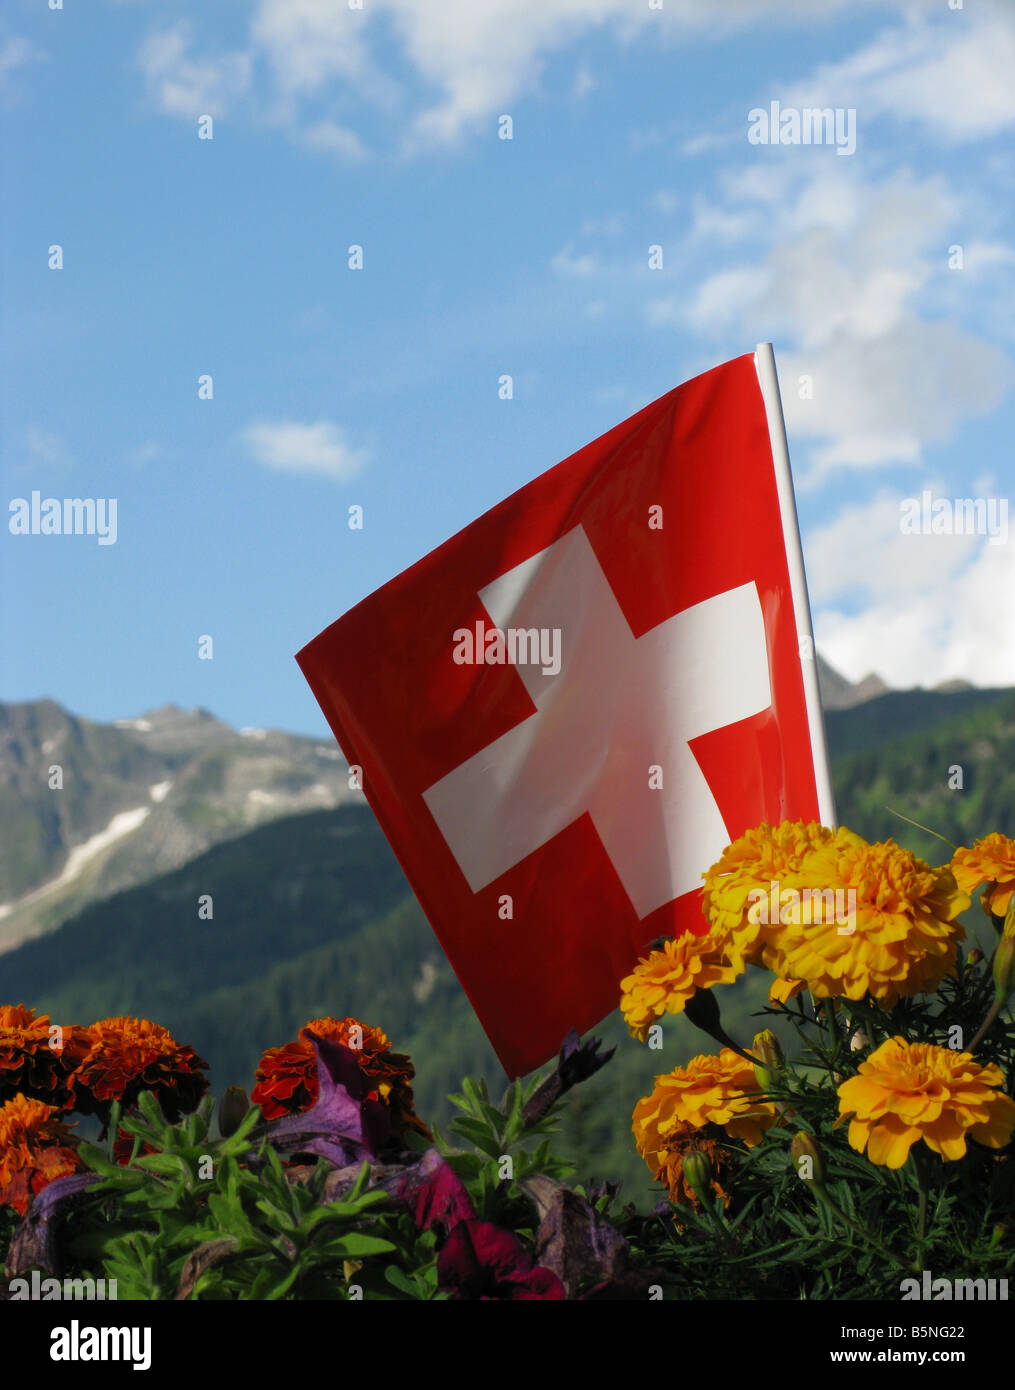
71;1017;209;1125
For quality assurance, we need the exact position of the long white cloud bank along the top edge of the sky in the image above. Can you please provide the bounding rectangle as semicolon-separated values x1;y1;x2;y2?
128;0;932;150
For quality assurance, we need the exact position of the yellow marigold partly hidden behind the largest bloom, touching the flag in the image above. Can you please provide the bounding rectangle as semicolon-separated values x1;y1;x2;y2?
701;820;833;965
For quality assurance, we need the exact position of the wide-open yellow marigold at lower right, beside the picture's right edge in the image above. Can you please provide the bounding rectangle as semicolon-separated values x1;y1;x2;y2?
836;1038;1015;1168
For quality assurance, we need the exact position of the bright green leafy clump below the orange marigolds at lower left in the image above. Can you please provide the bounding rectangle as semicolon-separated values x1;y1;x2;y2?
61;1093;396;1301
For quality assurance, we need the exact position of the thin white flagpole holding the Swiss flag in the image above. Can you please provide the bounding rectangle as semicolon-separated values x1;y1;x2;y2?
754;343;837;830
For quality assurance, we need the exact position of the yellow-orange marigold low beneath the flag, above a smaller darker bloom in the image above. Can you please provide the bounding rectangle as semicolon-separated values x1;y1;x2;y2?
631;1047;779;1156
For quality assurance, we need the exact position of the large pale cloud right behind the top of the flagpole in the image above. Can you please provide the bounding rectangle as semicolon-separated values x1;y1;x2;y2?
664;158;1015;472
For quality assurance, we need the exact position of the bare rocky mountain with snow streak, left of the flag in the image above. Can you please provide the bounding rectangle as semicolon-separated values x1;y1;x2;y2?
0;699;363;952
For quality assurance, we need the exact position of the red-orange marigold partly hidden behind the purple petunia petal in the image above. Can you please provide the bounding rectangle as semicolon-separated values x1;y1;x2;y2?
250;1017;432;1138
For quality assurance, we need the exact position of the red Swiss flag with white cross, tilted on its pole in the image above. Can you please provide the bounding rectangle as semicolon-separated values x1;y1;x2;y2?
296;354;823;1076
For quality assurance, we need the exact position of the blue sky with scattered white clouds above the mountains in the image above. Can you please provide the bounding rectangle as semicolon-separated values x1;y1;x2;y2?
0;0;1015;733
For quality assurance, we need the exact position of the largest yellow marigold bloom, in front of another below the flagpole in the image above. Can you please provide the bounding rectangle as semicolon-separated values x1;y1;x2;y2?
762;828;969;1004
